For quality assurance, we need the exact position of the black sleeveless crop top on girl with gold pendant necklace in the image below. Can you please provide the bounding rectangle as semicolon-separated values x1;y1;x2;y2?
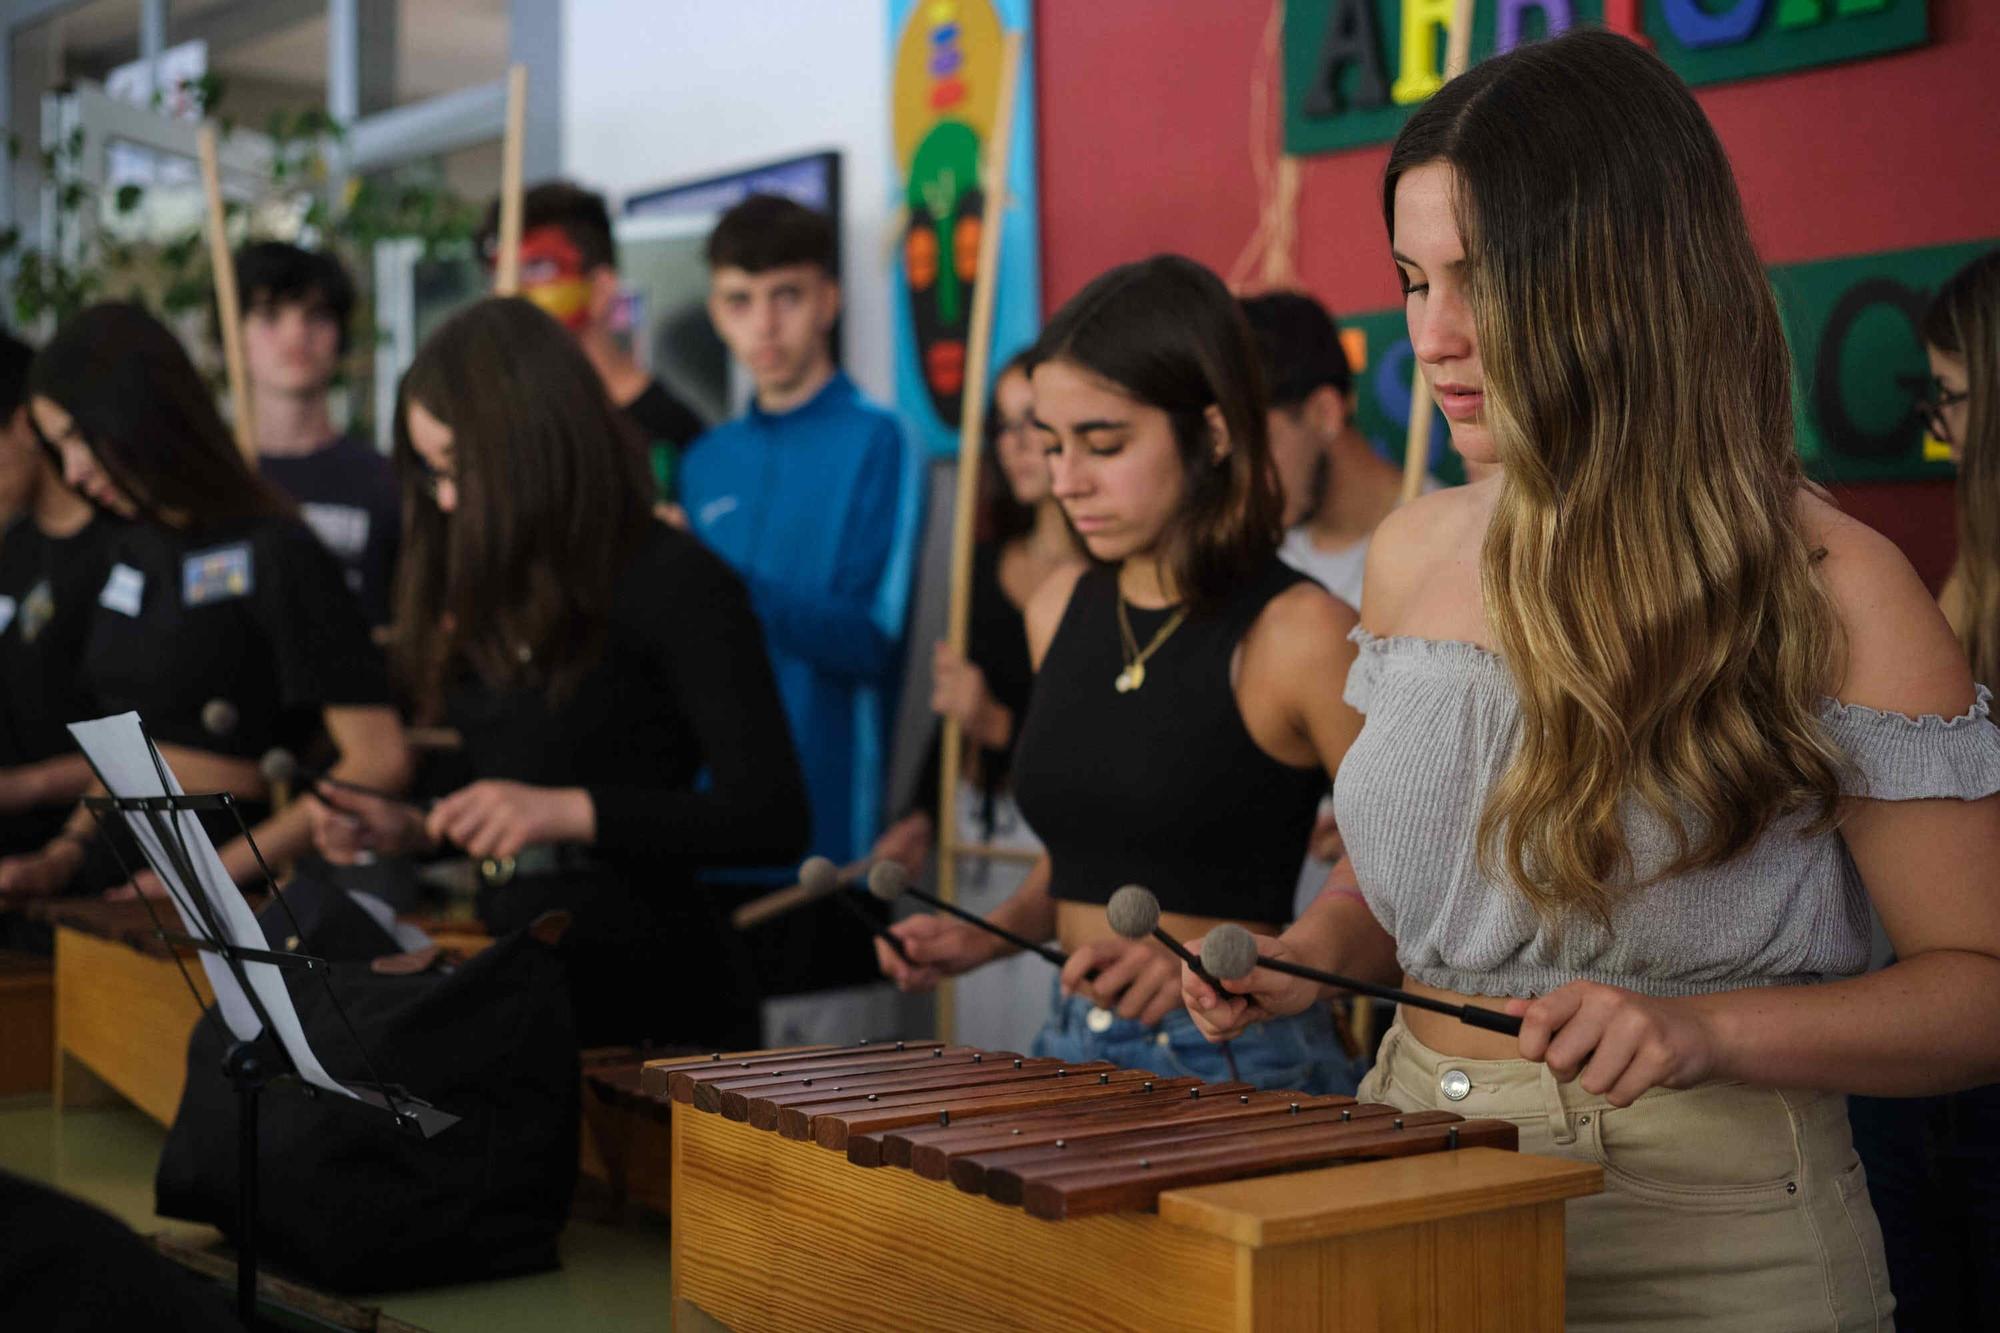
1014;556;1334;923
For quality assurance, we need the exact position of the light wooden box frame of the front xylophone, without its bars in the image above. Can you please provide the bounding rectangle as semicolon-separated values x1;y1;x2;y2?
672;1072;1600;1333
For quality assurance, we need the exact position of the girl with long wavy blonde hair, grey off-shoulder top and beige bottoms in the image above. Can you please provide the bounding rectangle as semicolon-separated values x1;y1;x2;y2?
1182;30;2000;1329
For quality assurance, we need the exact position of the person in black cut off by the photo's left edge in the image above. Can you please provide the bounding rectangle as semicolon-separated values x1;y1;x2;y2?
0;334;118;857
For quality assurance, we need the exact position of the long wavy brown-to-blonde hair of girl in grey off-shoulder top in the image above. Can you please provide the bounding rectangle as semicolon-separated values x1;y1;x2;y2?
1382;30;1846;921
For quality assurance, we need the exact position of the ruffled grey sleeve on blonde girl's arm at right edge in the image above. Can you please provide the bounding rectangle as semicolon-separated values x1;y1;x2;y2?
1820;685;2000;801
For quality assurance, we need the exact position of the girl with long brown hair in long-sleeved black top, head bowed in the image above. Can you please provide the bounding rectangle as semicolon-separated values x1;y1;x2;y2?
308;298;808;1045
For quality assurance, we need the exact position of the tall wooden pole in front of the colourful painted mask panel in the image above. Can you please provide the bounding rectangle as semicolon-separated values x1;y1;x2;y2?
938;32;1020;1037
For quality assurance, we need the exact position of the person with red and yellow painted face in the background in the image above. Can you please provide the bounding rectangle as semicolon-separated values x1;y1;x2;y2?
480;180;708;500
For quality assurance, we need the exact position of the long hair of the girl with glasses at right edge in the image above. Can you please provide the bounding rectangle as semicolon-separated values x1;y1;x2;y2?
1922;250;2000;685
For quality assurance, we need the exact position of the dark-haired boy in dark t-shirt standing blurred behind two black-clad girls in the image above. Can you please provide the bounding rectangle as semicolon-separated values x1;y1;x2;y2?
236;240;402;624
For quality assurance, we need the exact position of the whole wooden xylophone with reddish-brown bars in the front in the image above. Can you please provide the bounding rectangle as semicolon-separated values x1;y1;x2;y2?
644;1041;1600;1333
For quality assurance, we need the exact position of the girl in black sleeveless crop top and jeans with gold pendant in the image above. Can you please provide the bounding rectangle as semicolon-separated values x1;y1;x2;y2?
876;256;1360;1091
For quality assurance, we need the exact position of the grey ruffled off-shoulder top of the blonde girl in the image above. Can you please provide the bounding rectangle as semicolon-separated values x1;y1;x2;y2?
1334;630;2000;995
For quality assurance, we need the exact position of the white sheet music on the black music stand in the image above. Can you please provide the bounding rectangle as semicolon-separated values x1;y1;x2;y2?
70;713;360;1115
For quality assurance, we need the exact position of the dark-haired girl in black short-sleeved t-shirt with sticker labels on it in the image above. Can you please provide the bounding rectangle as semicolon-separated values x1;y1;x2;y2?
0;304;408;897
